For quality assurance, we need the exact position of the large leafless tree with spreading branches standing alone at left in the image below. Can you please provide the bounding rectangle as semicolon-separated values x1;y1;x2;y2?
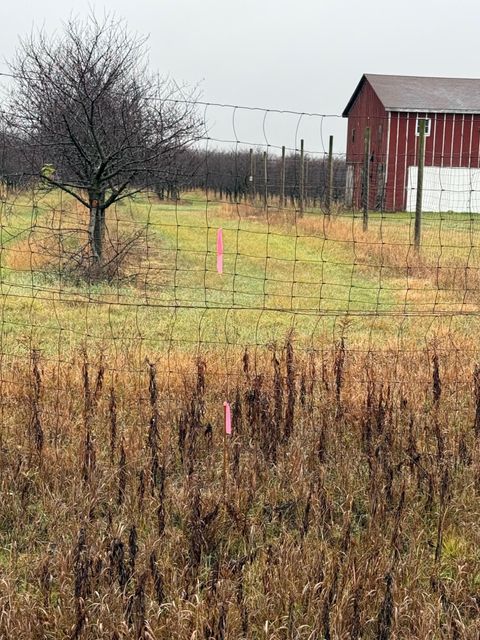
8;15;201;271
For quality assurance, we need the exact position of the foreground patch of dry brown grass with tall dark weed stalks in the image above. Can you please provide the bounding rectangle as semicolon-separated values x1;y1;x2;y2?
0;341;480;640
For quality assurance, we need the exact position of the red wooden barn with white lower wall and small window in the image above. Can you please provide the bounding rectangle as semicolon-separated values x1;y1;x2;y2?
343;74;480;211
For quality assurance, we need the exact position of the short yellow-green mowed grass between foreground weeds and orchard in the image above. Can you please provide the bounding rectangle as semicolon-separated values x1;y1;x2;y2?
0;194;480;359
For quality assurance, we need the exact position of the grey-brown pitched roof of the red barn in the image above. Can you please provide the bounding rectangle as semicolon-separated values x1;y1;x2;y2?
342;73;480;117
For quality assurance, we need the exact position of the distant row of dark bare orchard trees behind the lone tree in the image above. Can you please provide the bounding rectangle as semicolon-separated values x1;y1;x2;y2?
0;132;346;208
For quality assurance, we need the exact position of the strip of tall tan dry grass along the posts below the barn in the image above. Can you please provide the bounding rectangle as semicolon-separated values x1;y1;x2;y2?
218;203;480;312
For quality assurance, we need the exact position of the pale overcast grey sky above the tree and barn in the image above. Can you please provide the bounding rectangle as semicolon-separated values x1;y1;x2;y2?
0;0;480;152
